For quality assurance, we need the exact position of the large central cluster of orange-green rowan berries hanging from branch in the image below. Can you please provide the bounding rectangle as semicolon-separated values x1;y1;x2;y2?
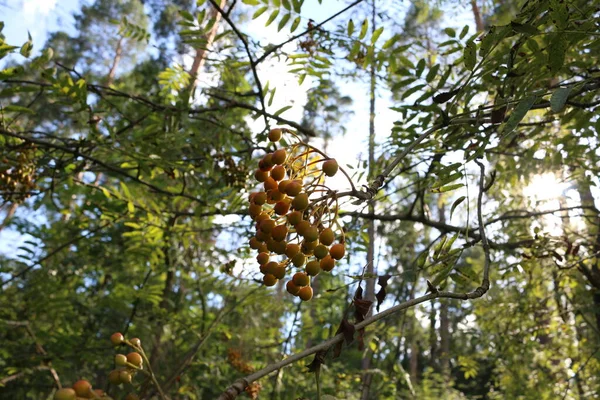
249;128;346;301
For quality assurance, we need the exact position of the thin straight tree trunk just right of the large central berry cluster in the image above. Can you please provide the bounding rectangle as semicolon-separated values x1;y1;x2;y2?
361;0;377;400
